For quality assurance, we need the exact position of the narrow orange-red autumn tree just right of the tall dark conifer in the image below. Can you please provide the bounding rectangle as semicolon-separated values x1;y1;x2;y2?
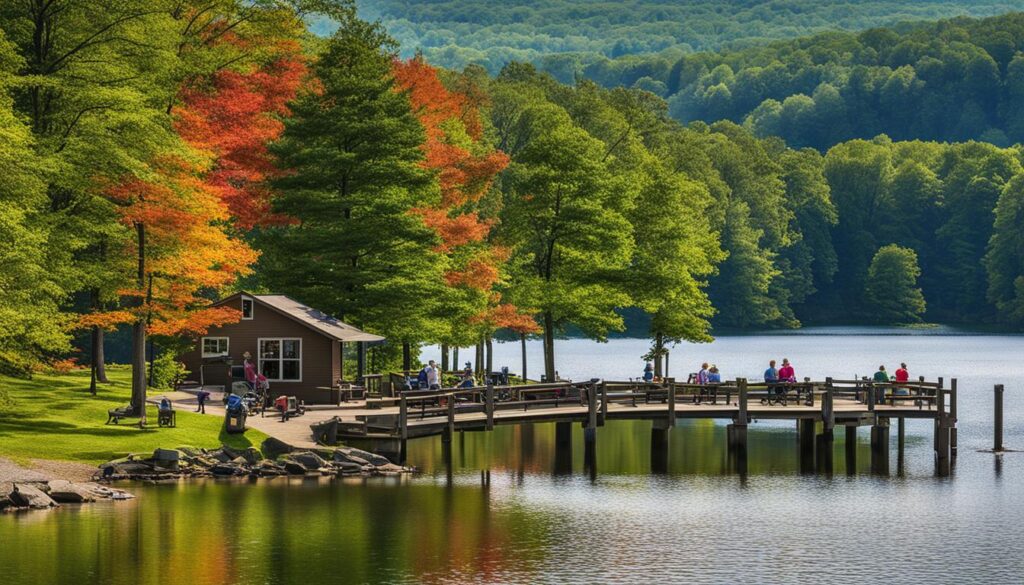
393;55;529;370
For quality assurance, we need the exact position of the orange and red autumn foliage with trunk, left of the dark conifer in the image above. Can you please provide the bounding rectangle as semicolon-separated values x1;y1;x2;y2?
83;13;305;411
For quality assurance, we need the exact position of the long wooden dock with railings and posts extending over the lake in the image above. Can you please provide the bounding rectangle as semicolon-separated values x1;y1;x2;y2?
313;378;956;475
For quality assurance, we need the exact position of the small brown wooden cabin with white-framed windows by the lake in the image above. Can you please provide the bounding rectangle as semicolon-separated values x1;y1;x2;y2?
181;292;384;404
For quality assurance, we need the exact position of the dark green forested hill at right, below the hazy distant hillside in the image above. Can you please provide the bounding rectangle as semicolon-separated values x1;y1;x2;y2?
584;12;1024;151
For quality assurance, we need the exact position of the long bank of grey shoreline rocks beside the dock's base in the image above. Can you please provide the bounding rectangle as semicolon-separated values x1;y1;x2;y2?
100;438;412;482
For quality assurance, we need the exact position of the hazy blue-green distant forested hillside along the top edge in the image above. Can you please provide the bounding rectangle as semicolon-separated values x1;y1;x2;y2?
329;0;1024;75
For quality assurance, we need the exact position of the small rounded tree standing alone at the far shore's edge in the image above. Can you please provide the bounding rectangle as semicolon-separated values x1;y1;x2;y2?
864;244;925;324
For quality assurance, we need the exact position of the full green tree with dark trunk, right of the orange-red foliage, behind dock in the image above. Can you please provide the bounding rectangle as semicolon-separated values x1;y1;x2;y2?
501;103;633;380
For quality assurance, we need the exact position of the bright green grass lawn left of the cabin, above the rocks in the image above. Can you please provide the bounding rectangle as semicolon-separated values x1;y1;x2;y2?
0;366;266;464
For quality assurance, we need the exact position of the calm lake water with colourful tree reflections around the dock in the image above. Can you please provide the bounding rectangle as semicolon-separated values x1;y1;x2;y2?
0;329;1024;585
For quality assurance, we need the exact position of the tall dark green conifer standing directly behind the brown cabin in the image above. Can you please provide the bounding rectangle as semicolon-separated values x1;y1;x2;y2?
259;17;445;366
